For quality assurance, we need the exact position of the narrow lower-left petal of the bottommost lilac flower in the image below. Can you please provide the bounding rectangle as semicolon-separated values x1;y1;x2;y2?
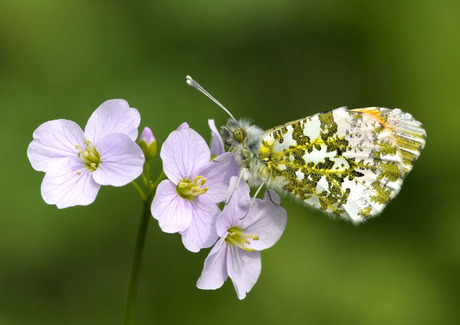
196;238;228;290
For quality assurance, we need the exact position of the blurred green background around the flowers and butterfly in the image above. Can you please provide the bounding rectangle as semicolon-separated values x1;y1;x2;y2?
0;0;460;324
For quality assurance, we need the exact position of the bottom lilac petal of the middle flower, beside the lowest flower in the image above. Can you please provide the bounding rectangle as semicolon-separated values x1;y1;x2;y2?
181;197;220;253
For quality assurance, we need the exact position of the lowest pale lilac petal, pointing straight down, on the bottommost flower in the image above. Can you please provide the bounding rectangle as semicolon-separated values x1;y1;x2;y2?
227;246;262;300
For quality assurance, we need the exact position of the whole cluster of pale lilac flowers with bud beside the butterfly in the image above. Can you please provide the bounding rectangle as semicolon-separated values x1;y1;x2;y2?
27;99;287;299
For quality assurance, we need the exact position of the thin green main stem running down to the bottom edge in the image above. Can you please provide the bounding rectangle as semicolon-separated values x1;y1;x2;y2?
123;200;151;325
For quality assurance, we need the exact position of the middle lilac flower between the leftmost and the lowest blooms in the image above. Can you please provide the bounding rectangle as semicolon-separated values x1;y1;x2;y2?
151;123;239;252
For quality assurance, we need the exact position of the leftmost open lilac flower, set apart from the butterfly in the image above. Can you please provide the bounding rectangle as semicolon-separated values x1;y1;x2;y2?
27;99;144;209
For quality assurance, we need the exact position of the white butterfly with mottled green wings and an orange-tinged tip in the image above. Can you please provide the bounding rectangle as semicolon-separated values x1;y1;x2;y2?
187;76;426;224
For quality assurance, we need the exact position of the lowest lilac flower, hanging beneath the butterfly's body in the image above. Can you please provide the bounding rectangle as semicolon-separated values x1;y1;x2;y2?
197;177;287;299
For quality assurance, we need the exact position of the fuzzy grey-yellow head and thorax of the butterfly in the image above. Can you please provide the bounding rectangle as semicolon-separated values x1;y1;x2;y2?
221;119;267;185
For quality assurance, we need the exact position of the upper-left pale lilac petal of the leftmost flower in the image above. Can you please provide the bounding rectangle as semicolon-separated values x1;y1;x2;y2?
27;119;85;172
